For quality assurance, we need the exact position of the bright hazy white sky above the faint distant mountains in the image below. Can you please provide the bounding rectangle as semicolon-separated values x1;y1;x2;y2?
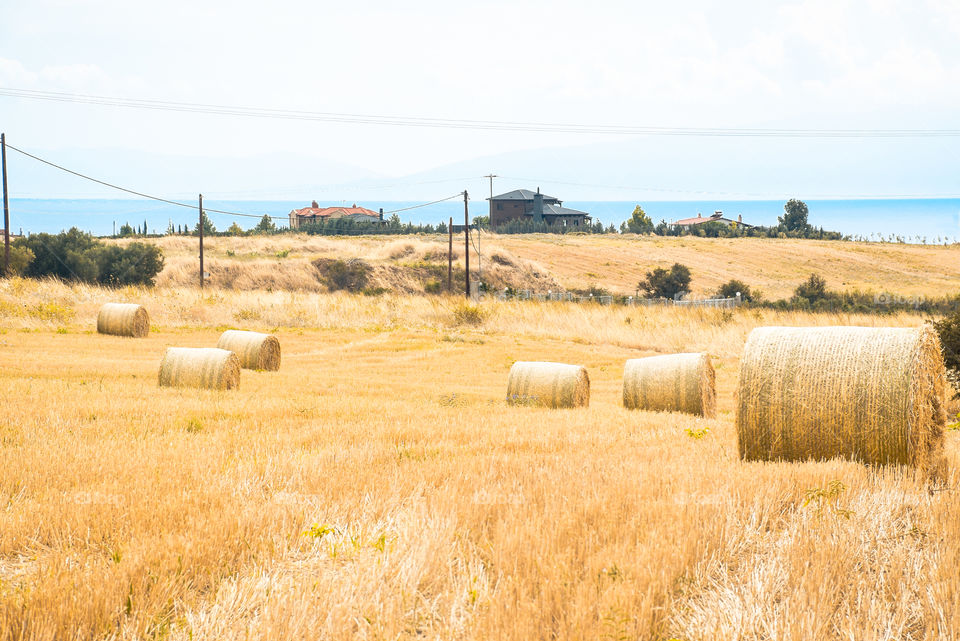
0;0;960;198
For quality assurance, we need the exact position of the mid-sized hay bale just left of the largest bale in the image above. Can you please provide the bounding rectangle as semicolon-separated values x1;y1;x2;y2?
623;354;717;418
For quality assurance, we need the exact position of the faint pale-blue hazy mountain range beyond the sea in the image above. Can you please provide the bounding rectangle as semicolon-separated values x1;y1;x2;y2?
7;137;960;203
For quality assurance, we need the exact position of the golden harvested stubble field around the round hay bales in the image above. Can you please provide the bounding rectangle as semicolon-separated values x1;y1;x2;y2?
0;279;960;641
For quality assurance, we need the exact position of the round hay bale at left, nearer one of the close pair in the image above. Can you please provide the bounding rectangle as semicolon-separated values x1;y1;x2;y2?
159;347;240;390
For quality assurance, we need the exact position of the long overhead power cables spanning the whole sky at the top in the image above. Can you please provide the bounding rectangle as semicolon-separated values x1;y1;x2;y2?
0;87;960;138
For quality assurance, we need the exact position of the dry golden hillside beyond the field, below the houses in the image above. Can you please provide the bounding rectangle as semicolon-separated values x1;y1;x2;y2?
139;233;960;299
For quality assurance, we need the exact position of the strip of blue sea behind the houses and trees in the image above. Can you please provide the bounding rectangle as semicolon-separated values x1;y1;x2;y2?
10;198;960;244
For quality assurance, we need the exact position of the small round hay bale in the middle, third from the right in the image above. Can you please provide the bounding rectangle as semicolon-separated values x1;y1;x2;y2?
507;361;590;407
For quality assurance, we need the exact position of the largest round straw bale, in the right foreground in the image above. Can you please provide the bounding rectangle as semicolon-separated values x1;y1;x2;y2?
737;327;946;470
